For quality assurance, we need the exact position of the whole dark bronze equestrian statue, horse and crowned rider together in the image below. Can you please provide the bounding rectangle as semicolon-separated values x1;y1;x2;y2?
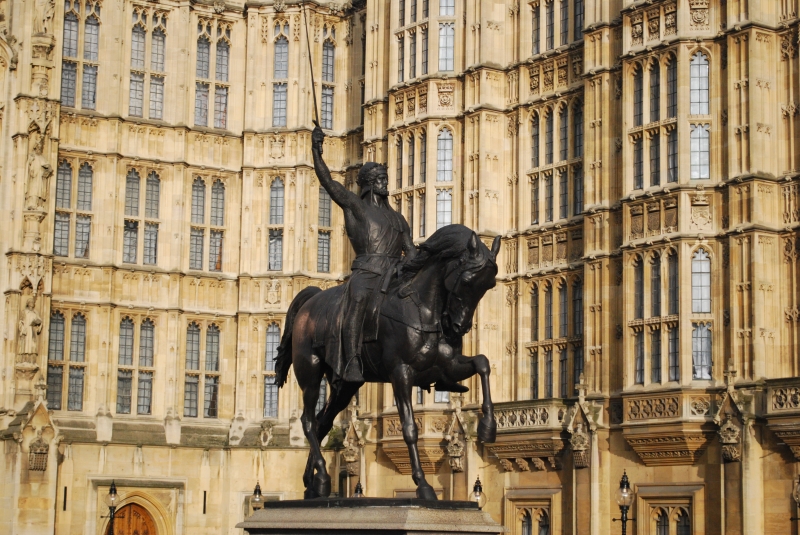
276;127;500;500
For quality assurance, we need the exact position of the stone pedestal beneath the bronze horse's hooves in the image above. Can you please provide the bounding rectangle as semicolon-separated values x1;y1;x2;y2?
236;498;506;535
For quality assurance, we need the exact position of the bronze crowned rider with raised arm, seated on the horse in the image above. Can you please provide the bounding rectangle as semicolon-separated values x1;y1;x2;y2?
311;126;417;383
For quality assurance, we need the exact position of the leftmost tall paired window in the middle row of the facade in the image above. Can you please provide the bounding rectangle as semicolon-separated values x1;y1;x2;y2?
53;161;94;258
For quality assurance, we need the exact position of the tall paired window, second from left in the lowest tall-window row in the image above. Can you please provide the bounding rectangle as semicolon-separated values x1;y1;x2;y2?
117;317;155;414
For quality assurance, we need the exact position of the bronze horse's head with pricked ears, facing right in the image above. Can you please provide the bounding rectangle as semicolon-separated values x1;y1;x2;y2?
442;232;500;336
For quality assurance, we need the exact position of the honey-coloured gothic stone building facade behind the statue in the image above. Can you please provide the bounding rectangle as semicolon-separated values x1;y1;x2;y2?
0;0;800;535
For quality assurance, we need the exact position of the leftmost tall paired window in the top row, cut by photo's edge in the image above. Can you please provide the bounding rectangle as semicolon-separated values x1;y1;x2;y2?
61;0;100;110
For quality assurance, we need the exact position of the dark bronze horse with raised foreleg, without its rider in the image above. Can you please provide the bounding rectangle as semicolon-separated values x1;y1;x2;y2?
275;225;500;500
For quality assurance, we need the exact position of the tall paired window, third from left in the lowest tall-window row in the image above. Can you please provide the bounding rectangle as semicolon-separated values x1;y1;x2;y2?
183;322;221;418
